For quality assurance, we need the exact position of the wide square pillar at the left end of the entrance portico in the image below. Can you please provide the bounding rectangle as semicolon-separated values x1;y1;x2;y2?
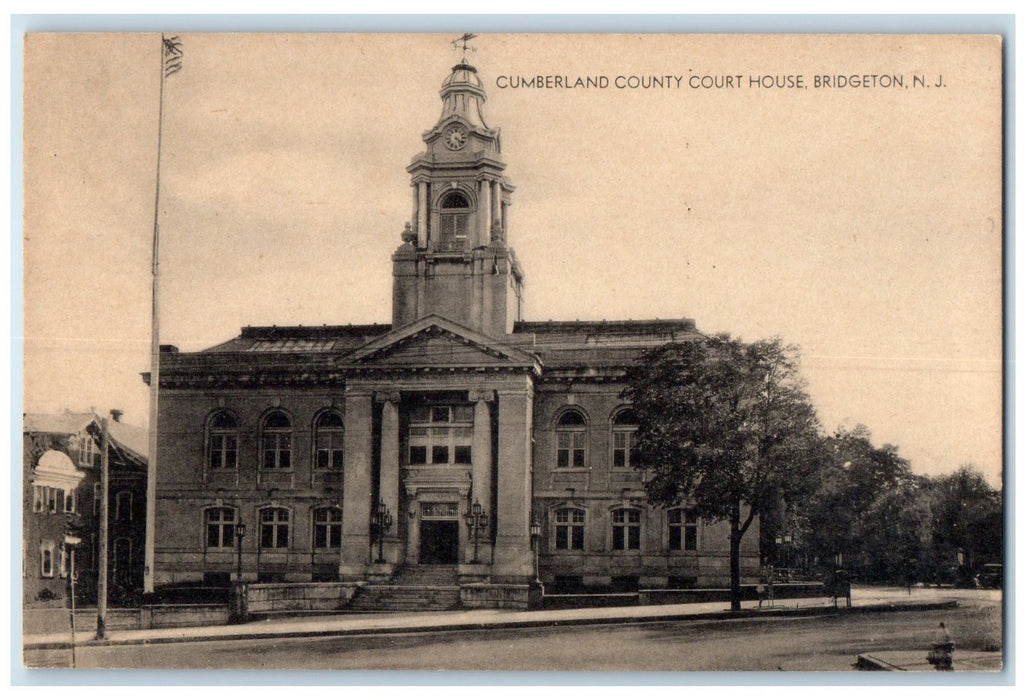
339;390;373;580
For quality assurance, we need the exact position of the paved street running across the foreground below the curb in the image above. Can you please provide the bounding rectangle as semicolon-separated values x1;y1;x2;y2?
27;589;1001;671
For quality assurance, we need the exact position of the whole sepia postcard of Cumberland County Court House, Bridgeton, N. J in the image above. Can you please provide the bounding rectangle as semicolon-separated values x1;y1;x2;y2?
21;32;1008;669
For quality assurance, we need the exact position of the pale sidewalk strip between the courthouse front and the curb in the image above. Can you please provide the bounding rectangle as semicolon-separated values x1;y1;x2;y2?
23;589;957;650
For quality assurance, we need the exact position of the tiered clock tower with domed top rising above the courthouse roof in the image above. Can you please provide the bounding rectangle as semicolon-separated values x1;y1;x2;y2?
392;59;523;337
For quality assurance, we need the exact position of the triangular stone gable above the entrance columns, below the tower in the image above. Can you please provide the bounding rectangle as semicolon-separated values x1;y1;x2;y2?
346;315;541;372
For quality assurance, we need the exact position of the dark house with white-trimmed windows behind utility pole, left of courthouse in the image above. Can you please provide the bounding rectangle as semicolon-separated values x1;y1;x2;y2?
23;411;148;606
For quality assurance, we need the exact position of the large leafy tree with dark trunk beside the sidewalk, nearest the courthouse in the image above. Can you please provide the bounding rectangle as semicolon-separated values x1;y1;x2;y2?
623;335;821;610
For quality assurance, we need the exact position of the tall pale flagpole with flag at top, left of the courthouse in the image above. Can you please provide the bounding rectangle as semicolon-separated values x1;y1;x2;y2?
143;34;174;593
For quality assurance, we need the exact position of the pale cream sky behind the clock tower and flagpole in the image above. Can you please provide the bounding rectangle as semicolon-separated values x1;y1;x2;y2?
24;34;1002;484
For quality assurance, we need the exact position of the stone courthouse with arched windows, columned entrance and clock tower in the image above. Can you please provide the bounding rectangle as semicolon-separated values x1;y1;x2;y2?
151;57;758;603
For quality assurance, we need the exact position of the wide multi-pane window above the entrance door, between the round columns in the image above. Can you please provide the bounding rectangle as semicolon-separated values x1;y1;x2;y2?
408;404;474;465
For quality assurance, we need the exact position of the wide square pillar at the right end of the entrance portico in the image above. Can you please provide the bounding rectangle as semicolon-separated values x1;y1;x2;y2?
492;388;534;583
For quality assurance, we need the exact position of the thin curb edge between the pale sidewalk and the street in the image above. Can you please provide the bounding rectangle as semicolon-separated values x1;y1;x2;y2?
23;600;958;651
